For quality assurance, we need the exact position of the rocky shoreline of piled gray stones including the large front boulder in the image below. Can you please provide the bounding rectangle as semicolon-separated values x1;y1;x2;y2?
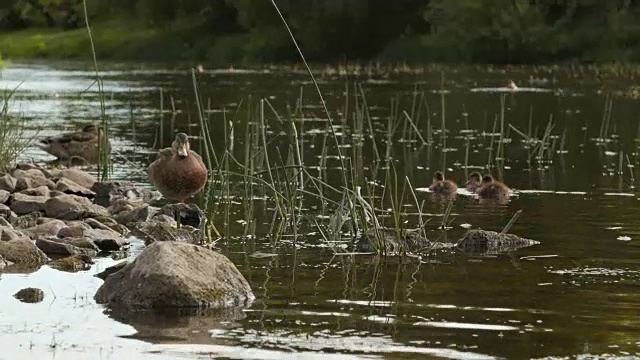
0;163;254;308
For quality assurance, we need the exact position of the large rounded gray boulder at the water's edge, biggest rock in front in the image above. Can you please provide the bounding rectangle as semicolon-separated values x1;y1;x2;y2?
94;241;255;309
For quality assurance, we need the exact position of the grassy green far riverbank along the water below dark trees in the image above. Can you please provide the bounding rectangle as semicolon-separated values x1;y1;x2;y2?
0;22;636;66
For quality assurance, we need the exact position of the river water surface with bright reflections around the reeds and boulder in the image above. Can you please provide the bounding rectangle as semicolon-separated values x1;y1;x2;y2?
0;64;640;359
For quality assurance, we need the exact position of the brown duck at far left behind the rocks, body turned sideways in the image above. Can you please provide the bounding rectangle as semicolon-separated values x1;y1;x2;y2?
36;124;111;162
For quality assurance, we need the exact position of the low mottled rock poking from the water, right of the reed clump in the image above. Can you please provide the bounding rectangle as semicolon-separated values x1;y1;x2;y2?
456;229;540;255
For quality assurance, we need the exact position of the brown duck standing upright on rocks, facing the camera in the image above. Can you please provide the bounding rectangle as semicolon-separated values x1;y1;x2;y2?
149;133;208;203
